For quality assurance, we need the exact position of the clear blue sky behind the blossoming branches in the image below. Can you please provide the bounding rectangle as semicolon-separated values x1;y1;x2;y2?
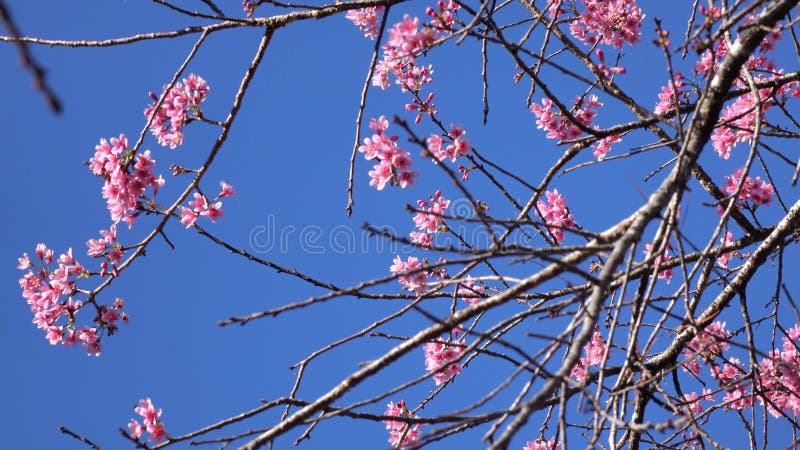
0;0;796;449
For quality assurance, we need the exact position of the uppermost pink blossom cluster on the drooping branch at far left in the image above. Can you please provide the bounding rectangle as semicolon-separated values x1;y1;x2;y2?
144;73;209;148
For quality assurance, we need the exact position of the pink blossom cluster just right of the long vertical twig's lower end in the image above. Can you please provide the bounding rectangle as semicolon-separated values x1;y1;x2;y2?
358;116;419;191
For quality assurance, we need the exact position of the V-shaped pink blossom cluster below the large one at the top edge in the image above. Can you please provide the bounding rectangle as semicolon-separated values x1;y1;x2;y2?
531;95;603;141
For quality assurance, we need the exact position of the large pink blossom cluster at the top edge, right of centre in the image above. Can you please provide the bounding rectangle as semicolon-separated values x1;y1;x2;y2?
568;0;645;49
